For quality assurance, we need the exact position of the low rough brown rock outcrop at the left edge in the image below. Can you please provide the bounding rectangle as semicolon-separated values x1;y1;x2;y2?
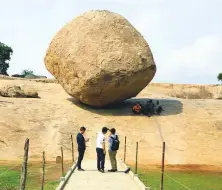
0;85;39;98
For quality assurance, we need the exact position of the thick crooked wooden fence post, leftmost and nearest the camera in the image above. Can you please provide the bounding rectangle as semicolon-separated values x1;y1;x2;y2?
20;138;29;190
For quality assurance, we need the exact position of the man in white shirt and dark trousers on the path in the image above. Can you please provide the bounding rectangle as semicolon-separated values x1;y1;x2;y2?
96;127;108;173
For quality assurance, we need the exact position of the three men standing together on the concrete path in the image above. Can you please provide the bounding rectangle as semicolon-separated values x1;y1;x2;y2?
76;127;120;173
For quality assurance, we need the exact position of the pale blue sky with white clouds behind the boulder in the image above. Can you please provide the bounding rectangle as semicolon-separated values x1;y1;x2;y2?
0;0;222;84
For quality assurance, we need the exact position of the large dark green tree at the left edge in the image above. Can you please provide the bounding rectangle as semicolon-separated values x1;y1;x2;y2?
0;42;13;75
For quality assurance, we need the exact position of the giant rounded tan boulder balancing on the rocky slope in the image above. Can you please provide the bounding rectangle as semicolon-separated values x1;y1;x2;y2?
45;11;156;107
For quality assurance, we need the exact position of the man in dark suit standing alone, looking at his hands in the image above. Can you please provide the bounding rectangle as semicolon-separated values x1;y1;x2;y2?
76;127;89;171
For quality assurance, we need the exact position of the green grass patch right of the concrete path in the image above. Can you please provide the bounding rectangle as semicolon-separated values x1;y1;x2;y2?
135;169;222;190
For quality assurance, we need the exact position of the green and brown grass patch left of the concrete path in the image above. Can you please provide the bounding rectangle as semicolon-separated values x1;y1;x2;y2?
0;162;72;190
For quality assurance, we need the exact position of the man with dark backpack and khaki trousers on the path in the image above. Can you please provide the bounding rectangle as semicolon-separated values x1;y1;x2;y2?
108;128;120;172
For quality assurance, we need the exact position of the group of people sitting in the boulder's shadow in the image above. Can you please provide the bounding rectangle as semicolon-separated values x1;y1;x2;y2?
132;100;163;117
